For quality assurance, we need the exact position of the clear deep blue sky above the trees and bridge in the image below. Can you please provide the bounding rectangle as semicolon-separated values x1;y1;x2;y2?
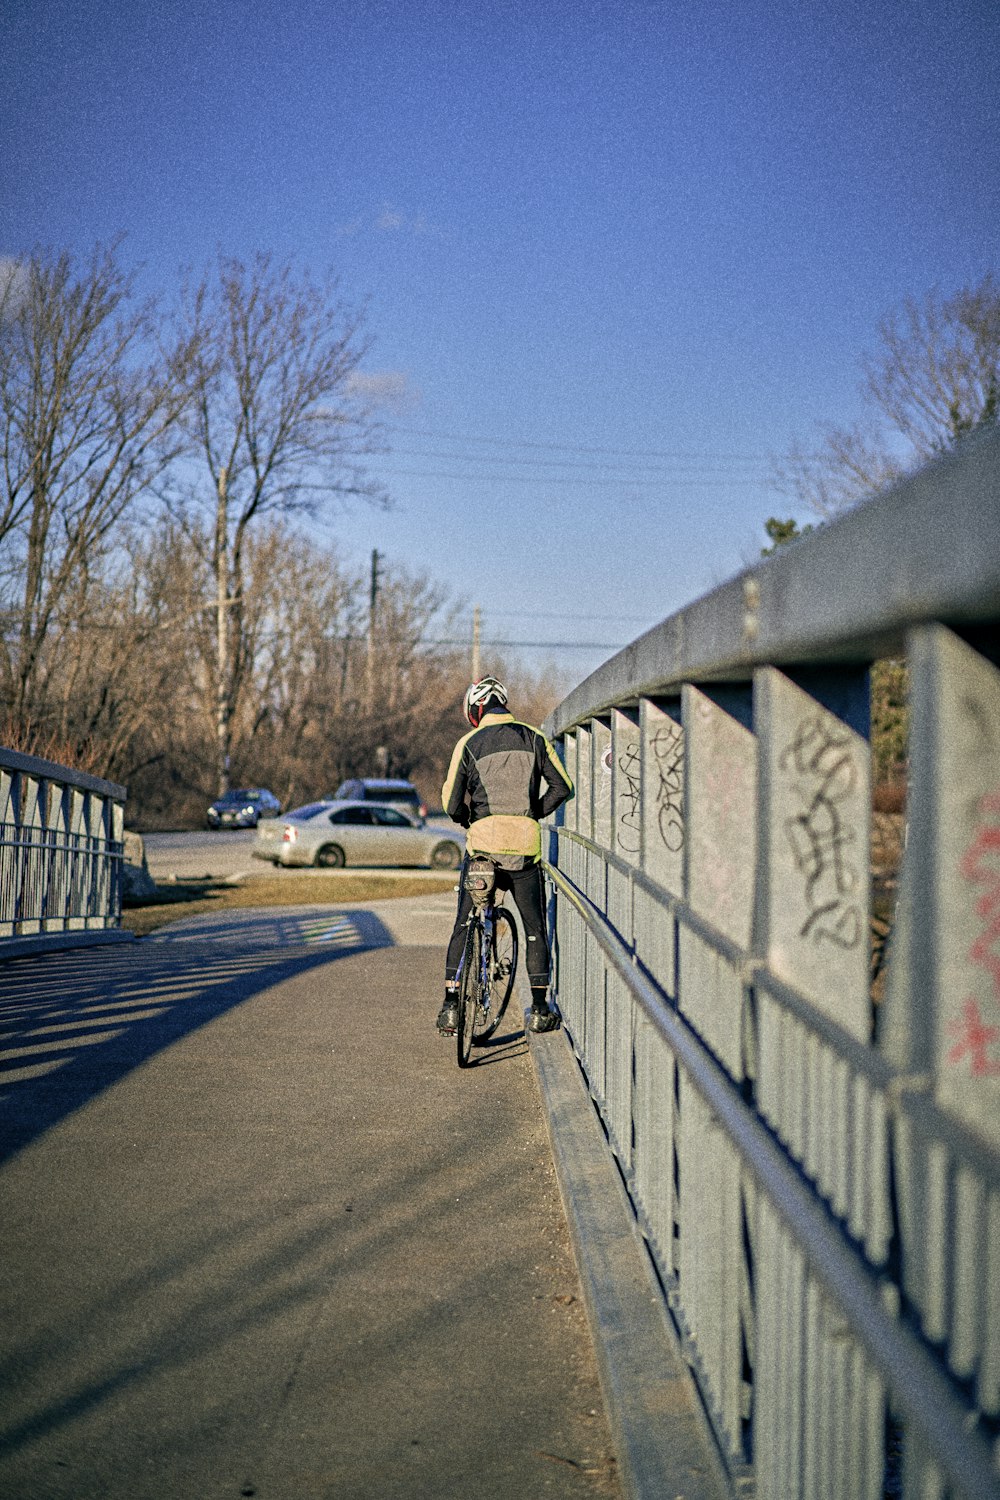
0;0;1000;678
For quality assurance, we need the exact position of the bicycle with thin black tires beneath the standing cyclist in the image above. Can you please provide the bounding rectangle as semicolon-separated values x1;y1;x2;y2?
456;858;517;1068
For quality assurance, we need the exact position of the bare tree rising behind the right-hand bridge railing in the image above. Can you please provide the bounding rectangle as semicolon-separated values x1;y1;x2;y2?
775;273;1000;516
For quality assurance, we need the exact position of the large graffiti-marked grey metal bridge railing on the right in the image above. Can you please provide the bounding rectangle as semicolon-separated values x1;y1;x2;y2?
547;428;1000;1500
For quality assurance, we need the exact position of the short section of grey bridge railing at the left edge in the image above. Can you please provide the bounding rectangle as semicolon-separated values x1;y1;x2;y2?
0;749;126;959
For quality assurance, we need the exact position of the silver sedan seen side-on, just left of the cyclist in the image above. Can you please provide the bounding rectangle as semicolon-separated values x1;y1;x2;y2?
252;800;465;870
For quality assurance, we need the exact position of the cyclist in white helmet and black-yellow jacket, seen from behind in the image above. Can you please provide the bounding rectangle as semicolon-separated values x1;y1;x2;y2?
438;677;573;1037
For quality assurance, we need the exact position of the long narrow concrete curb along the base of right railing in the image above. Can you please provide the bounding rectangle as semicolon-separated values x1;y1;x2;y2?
531;1031;733;1500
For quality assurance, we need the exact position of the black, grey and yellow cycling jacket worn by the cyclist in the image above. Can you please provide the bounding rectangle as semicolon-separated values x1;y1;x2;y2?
441;714;573;864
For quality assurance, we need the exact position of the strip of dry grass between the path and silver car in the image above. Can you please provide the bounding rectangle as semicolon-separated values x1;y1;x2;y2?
121;875;448;938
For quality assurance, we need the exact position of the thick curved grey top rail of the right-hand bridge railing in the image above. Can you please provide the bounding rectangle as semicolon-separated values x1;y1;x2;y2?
546;423;1000;737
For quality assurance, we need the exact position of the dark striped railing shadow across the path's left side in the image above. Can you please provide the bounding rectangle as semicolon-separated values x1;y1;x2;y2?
0;909;394;1163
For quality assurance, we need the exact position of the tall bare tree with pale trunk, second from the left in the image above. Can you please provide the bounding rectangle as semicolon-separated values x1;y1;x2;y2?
172;255;384;791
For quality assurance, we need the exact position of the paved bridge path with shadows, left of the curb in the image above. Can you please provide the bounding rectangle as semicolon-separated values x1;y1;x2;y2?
0;893;619;1500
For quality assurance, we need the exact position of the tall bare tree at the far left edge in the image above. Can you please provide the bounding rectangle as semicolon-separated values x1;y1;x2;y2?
0;246;192;722
